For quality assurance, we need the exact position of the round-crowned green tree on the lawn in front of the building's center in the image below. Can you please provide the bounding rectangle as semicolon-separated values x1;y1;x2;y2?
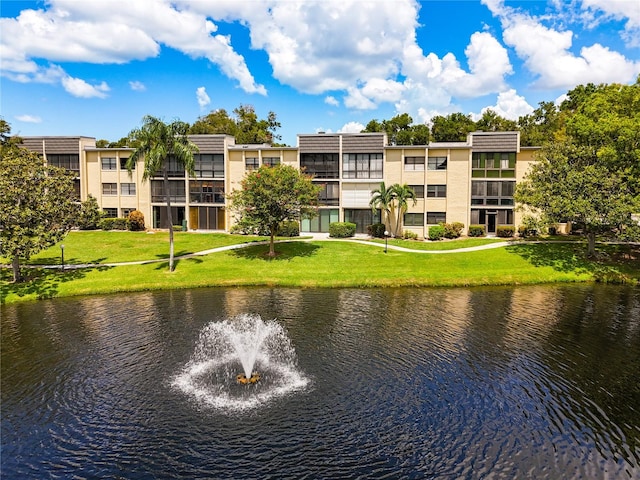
228;165;320;257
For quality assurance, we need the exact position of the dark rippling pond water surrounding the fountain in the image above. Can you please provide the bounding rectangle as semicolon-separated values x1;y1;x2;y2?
1;286;640;479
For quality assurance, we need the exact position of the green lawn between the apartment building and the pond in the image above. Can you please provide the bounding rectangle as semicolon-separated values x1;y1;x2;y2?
0;232;640;303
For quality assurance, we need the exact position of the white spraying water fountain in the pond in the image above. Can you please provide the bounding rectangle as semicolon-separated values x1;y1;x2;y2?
173;314;308;411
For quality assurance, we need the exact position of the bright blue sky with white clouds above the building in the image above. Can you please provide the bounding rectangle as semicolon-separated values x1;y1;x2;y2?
0;0;640;146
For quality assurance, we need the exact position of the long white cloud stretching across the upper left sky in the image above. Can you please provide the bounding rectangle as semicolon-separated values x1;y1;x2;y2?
0;0;266;95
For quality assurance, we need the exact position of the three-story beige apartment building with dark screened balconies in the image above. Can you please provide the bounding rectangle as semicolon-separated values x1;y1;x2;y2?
23;132;538;238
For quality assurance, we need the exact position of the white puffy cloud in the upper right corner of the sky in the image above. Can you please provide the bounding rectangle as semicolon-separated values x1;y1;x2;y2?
484;0;640;89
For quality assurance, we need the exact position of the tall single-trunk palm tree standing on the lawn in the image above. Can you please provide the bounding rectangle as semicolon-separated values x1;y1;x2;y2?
126;115;198;272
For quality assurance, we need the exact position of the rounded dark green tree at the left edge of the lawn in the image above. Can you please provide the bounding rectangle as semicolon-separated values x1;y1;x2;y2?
0;145;77;282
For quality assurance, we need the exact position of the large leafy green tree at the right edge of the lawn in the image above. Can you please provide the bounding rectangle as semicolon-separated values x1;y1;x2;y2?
515;81;640;256
